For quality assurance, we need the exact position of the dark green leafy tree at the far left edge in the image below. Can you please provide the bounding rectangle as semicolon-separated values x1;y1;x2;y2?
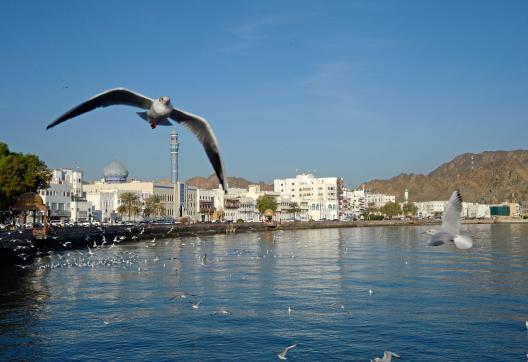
0;142;51;210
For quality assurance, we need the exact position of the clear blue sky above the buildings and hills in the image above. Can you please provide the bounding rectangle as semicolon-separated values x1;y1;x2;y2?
0;0;528;186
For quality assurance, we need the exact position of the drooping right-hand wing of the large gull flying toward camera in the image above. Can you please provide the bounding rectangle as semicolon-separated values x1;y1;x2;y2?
169;108;227;192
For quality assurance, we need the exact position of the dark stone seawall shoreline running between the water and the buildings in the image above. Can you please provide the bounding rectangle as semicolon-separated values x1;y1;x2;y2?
0;219;498;265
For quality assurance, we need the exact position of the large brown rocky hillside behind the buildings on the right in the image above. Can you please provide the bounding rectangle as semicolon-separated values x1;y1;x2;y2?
360;150;528;203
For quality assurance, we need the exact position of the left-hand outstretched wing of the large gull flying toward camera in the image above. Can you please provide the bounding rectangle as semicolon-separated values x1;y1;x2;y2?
46;88;152;129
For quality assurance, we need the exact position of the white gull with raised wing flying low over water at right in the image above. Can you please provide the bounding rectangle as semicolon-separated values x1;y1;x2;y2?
427;191;473;249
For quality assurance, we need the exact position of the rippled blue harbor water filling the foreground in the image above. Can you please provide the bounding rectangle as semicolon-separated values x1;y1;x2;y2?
0;224;528;361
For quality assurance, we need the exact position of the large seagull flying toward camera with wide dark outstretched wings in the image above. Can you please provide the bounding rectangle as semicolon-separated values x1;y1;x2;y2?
46;88;227;192
